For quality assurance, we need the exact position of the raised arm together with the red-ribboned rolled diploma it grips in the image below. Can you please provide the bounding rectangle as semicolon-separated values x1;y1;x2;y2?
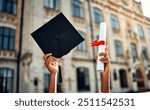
91;22;110;93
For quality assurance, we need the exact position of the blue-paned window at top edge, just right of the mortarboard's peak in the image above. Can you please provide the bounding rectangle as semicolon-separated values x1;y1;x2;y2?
72;0;84;18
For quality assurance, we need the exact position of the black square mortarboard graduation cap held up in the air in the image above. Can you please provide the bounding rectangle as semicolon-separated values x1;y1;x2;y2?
31;13;84;58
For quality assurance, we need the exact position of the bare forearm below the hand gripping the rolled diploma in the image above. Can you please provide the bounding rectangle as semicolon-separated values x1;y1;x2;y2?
101;73;110;93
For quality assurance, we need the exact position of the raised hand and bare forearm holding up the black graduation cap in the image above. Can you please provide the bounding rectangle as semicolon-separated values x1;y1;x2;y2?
44;54;59;93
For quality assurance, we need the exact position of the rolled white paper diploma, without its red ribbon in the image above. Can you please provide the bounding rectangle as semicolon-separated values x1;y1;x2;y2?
97;22;106;72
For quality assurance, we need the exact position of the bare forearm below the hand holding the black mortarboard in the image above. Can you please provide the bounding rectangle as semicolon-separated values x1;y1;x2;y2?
49;74;57;93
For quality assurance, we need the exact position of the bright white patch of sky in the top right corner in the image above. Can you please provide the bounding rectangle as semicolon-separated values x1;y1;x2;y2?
136;0;150;18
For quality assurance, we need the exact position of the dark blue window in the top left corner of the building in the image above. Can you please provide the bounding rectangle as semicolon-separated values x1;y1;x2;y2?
0;0;17;15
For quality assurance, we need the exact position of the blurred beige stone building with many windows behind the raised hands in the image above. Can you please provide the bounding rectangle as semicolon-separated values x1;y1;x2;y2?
0;0;150;93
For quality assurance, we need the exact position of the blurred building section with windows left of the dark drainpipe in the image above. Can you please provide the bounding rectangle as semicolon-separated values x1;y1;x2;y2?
0;0;21;92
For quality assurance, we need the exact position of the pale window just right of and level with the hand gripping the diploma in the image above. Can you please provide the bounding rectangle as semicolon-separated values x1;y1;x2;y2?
115;40;123;56
